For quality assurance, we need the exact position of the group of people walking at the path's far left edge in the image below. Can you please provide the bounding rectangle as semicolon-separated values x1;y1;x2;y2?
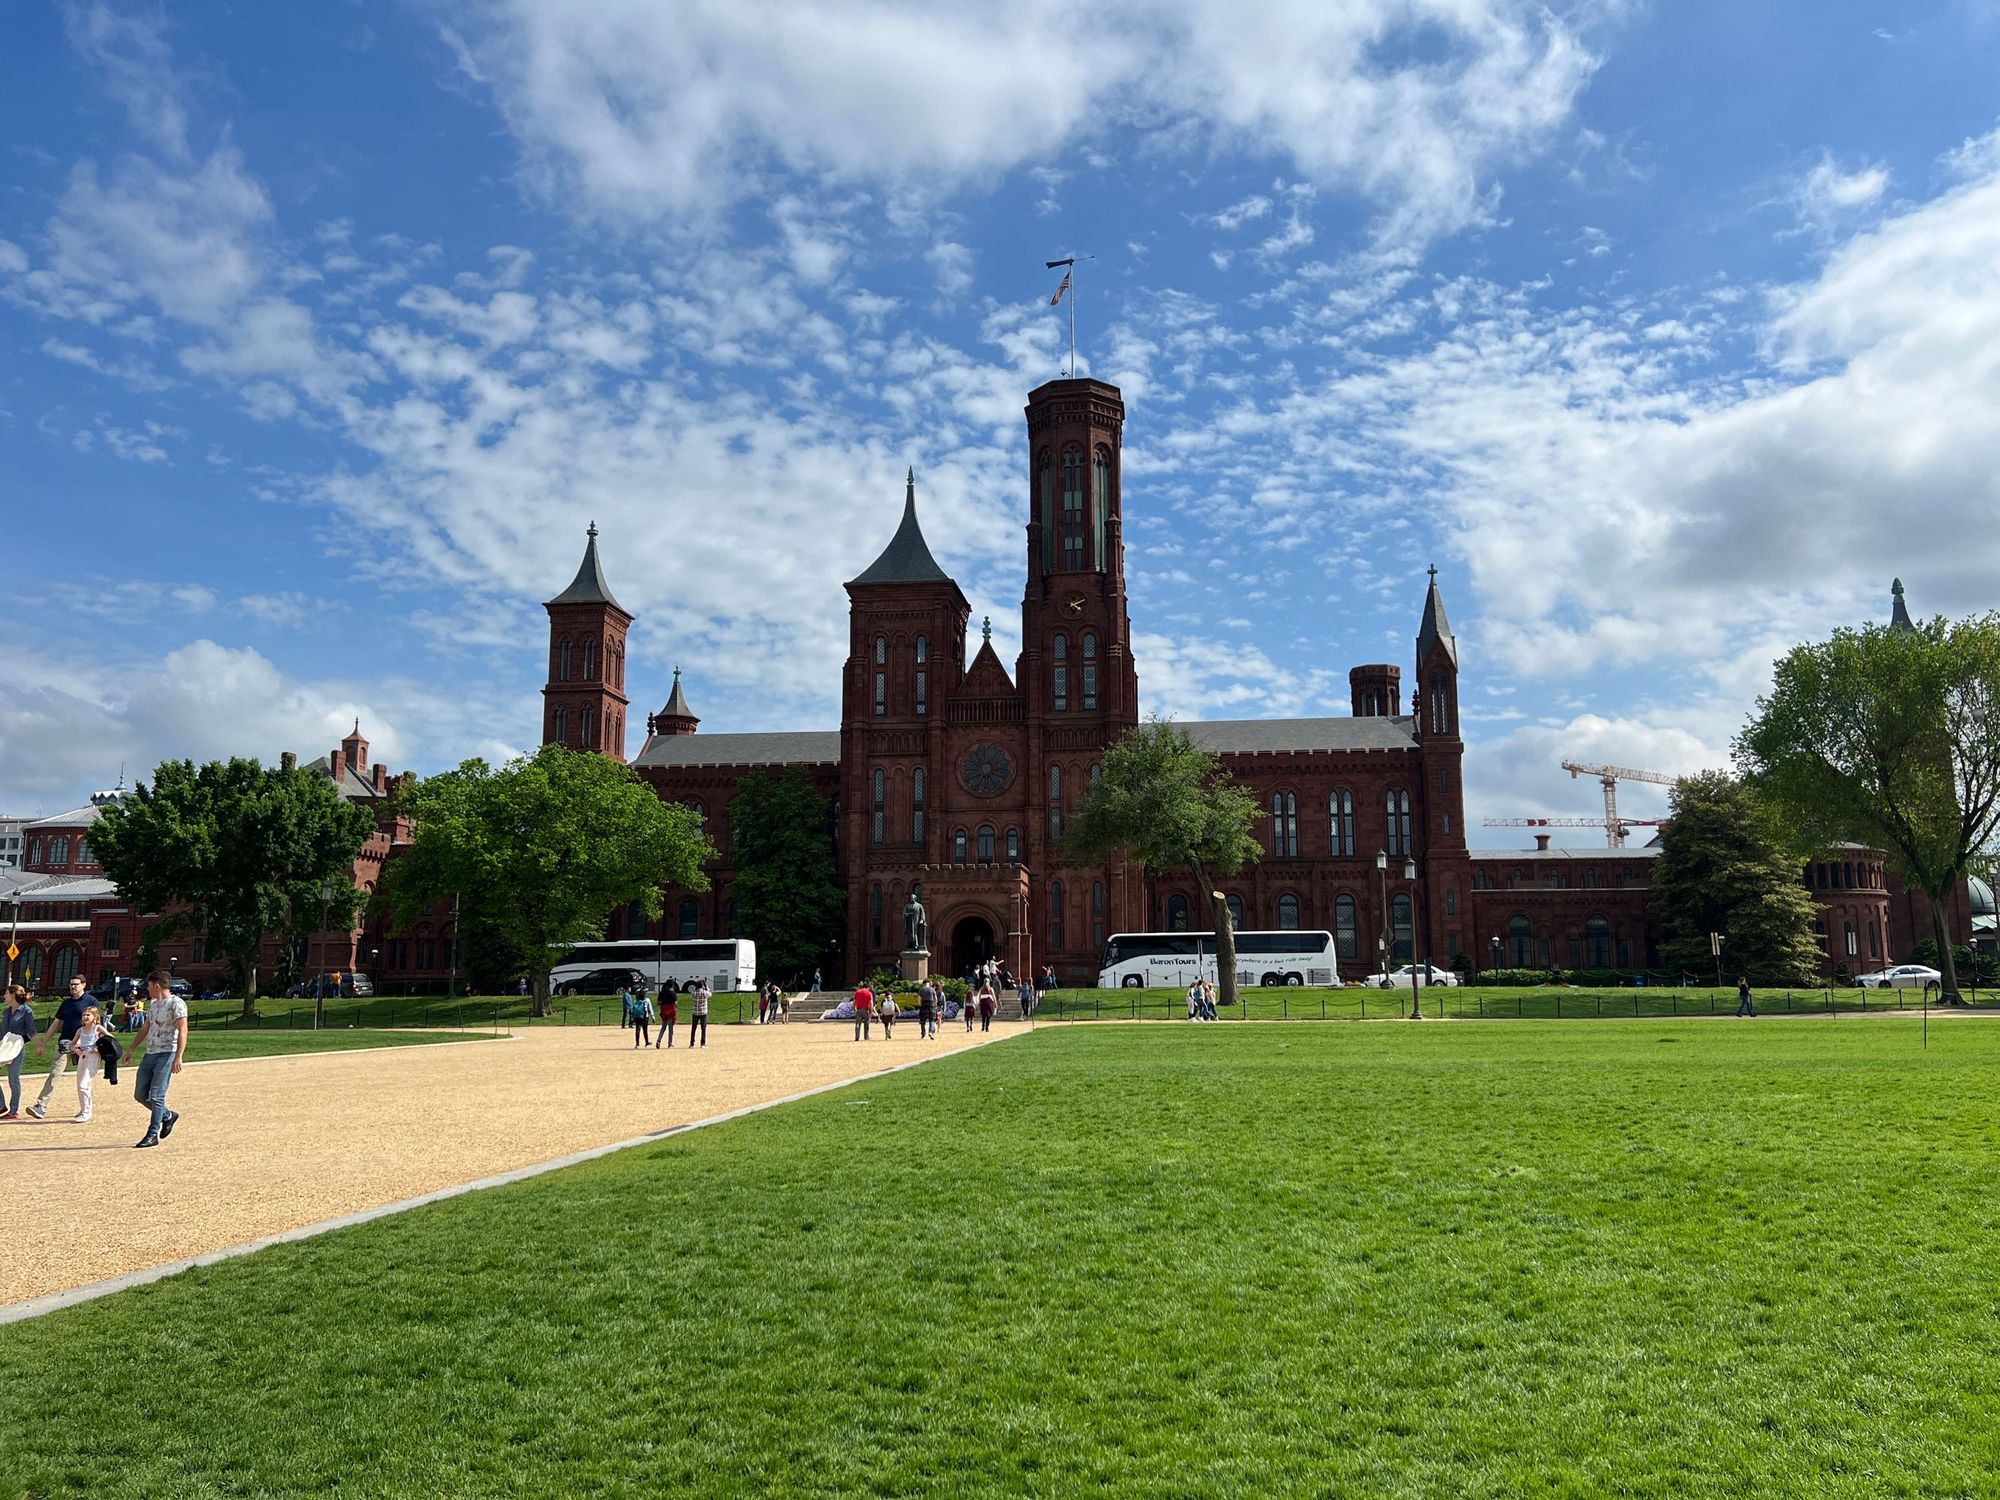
0;970;188;1146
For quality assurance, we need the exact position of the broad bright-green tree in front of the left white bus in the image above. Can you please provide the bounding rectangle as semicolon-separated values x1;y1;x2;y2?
380;744;714;1016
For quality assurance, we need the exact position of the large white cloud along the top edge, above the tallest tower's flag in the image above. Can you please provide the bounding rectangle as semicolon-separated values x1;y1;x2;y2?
458;0;1616;246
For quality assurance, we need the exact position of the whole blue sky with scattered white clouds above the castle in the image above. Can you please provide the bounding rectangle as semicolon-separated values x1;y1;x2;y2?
0;0;2000;844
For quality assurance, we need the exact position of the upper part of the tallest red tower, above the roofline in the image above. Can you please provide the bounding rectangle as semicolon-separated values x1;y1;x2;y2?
1018;380;1138;738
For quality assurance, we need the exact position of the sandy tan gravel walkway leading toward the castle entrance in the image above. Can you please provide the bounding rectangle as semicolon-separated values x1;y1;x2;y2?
0;1020;1020;1306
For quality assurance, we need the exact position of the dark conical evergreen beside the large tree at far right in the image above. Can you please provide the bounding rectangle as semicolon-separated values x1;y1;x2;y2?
1652;770;1820;984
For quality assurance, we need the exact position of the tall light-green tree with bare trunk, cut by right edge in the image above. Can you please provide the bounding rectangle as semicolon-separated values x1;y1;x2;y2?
1736;614;2000;1002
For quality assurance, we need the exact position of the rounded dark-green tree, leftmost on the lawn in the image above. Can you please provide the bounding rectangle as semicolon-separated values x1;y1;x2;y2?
90;758;374;1016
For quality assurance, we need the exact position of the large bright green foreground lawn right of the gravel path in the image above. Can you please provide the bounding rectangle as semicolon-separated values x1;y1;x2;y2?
0;1020;2000;1498
